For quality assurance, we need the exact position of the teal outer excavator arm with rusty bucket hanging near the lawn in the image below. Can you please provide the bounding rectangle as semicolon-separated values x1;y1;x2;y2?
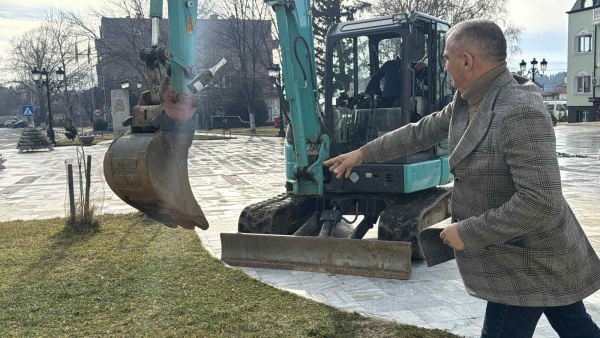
104;0;213;229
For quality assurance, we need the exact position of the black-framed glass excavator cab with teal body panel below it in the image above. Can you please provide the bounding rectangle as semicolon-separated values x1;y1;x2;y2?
325;12;453;194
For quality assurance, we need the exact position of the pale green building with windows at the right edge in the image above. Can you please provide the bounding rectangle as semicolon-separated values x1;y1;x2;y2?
567;0;600;123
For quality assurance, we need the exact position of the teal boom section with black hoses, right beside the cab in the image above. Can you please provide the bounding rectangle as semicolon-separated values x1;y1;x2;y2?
265;0;330;195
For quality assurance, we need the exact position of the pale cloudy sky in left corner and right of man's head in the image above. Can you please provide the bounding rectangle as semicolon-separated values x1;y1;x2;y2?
0;0;575;75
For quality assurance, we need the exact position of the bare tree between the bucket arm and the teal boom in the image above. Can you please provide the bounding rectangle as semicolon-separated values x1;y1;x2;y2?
210;0;275;131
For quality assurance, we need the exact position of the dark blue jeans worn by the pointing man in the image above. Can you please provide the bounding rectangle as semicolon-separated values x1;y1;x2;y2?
481;301;600;338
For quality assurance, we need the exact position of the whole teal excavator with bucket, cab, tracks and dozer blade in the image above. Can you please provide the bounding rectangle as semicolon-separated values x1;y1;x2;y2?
104;0;453;279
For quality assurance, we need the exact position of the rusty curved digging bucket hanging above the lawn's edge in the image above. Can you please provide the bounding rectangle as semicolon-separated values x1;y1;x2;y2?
104;131;208;229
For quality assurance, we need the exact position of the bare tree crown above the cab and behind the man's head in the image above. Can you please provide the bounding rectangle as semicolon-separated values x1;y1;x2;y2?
373;0;522;55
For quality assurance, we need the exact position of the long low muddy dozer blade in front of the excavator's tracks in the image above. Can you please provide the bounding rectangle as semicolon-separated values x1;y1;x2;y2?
221;233;412;279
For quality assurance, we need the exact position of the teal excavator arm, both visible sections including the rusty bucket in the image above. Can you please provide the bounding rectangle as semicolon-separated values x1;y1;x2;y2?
104;0;329;229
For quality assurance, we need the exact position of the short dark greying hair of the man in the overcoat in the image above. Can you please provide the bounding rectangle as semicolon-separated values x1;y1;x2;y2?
447;19;506;62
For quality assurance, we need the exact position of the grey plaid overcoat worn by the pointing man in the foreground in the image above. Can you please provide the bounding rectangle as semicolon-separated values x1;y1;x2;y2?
363;69;600;306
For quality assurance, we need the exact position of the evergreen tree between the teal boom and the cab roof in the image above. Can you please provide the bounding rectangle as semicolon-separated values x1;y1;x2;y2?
311;0;371;89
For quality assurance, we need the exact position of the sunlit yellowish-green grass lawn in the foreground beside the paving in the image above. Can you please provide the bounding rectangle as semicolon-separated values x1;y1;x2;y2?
0;213;456;338
